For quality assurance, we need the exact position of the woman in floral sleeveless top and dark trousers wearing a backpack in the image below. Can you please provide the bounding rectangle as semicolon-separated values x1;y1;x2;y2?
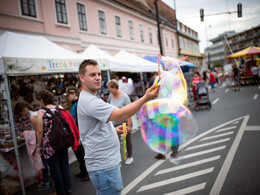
36;90;74;194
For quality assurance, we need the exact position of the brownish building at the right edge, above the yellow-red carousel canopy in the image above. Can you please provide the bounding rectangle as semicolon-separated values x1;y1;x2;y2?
227;25;260;55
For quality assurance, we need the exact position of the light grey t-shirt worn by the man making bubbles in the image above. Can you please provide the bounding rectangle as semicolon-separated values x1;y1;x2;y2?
77;90;121;171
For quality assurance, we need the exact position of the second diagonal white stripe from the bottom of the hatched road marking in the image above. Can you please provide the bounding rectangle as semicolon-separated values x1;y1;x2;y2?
137;167;214;192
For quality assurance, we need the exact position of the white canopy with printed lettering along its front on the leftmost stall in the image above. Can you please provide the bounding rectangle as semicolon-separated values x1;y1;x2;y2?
0;32;82;76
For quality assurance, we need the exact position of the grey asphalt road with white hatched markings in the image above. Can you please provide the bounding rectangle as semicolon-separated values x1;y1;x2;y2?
18;82;260;195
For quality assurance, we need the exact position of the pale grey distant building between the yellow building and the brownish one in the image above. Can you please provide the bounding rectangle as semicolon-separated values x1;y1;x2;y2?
205;31;235;68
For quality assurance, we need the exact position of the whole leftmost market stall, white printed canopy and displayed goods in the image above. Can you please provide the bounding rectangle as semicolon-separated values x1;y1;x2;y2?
0;32;85;194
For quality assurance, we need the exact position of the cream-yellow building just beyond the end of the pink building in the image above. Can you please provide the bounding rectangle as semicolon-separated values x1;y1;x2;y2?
177;22;203;69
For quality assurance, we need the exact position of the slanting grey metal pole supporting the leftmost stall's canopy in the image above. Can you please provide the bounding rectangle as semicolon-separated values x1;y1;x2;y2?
4;75;25;195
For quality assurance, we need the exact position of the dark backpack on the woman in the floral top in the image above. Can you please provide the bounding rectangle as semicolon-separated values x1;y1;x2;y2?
44;107;74;150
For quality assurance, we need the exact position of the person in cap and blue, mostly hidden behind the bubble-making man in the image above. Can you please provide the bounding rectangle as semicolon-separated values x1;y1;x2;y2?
65;86;89;182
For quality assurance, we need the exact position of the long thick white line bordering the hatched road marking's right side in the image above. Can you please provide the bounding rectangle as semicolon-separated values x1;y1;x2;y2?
210;115;250;195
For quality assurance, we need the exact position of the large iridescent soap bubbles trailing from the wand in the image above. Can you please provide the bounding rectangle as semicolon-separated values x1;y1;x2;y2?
139;55;198;154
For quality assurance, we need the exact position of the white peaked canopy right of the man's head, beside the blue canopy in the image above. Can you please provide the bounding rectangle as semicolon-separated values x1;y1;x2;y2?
110;50;158;72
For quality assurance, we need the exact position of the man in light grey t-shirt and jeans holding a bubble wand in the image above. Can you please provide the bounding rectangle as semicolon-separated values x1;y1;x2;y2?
77;60;159;194
